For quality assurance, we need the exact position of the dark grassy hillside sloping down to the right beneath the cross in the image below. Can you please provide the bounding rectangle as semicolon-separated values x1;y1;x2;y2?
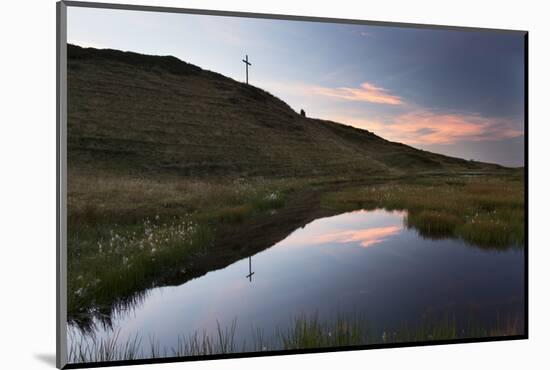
67;45;498;177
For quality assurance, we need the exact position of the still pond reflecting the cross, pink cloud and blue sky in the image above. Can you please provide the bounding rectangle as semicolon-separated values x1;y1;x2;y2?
70;210;524;356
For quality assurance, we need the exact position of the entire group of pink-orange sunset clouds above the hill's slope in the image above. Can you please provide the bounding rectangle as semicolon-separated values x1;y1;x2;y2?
260;82;523;146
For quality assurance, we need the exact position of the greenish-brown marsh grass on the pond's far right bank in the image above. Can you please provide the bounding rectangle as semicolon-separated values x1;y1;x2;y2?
323;175;525;248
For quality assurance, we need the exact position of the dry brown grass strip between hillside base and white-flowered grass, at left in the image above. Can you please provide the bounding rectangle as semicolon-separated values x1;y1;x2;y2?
68;171;298;225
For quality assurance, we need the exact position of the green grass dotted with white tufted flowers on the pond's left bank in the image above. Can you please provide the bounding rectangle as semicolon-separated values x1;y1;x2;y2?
67;216;212;324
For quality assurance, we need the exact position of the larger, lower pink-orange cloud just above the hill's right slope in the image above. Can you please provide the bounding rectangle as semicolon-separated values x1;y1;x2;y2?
337;109;523;145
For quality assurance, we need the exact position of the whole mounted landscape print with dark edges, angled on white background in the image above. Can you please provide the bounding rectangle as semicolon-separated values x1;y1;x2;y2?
57;1;528;368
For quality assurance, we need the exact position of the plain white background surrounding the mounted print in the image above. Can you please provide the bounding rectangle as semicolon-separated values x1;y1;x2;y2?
0;0;550;370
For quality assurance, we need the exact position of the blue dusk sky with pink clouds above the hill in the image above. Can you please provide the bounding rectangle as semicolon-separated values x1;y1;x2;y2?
67;7;524;166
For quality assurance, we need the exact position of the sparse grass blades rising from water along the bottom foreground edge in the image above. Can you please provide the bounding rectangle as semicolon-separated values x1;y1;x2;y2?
68;315;523;363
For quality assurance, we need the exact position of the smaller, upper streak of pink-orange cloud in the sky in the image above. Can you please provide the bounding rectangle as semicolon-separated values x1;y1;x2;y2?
304;82;403;105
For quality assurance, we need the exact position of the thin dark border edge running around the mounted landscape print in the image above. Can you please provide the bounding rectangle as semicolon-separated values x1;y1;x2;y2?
56;1;529;369
